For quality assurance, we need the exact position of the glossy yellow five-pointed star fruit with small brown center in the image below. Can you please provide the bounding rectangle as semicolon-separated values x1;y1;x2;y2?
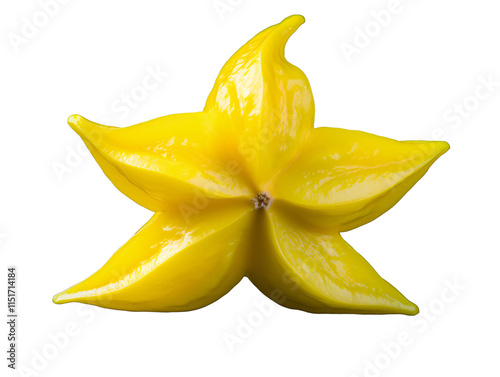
54;16;449;315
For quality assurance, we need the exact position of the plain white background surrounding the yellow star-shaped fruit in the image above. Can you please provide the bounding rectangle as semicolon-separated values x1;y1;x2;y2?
0;0;500;377
